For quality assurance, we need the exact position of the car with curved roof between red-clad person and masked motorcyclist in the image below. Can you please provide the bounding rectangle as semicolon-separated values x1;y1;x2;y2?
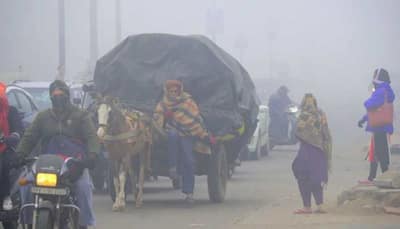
6;85;39;128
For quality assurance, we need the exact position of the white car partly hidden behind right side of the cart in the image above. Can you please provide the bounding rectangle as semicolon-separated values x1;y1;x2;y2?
247;105;269;160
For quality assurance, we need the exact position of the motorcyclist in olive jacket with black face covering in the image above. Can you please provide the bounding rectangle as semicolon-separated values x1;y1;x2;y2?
17;80;99;228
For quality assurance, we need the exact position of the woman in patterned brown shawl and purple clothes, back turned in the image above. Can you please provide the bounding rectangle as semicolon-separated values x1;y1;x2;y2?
292;94;332;214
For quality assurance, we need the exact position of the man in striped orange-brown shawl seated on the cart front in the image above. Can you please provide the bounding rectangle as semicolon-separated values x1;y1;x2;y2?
154;80;216;204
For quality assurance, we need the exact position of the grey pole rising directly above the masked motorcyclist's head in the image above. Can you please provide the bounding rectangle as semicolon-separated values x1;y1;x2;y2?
56;0;65;80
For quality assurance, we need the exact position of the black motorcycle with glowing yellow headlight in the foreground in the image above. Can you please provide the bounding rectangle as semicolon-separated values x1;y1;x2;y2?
20;154;83;229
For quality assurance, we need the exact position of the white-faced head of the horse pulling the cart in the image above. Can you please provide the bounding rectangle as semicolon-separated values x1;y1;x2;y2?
97;96;115;138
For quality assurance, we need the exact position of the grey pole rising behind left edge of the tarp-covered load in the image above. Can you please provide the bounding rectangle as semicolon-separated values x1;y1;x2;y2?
89;0;98;77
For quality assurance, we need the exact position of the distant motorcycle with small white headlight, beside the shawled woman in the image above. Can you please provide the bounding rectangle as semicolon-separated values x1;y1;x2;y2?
269;104;300;150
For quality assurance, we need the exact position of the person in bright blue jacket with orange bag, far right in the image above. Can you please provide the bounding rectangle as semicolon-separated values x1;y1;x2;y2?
358;68;395;185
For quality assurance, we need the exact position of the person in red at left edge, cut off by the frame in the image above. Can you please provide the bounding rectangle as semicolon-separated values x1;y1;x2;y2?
0;82;23;229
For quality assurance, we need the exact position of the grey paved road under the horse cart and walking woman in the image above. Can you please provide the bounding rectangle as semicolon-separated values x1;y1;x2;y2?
91;148;400;229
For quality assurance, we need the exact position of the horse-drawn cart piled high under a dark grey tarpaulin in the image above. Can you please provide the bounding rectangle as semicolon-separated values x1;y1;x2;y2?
93;34;259;207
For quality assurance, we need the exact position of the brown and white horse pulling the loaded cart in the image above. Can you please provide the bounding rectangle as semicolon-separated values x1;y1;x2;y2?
97;96;152;211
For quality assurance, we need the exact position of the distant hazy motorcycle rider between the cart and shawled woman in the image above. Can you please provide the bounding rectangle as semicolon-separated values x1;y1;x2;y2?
268;85;292;142
